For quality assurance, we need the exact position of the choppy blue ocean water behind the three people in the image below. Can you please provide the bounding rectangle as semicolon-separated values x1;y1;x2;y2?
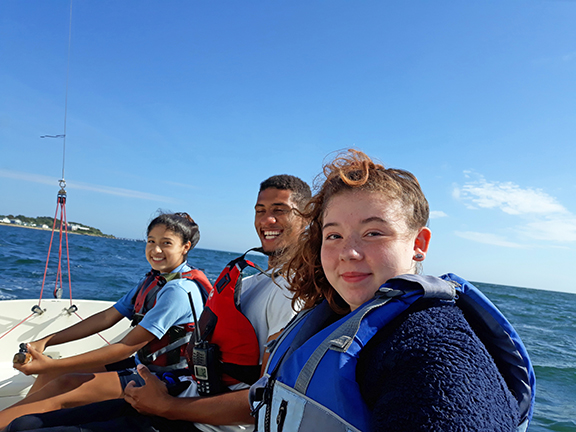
0;225;576;432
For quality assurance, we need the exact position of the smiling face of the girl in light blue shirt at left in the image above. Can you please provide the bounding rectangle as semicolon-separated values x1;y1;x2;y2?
146;224;190;273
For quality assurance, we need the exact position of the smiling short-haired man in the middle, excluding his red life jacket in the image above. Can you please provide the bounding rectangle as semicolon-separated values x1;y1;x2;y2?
7;175;311;432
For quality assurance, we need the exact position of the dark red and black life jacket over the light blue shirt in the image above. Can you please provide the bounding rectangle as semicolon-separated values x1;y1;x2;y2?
132;269;212;371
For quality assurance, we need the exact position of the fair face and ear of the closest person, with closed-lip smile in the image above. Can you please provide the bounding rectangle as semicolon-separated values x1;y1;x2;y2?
321;191;430;310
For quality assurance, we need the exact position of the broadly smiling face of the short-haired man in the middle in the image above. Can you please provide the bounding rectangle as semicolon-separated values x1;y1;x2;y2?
254;188;302;264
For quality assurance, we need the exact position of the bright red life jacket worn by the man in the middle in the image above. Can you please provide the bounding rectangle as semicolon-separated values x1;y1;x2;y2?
194;254;264;386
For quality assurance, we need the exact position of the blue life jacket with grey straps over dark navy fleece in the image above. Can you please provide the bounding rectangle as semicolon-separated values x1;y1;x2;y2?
251;274;535;432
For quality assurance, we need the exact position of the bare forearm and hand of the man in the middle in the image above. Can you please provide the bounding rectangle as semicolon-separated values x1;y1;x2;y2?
124;332;280;426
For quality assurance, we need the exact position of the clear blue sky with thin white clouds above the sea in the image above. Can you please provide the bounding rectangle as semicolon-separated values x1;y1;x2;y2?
0;0;576;293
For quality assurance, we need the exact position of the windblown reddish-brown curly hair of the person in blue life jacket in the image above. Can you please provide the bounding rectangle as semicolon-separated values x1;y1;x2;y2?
283;149;430;313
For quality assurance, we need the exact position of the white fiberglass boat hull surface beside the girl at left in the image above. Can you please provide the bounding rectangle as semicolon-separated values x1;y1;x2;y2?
0;299;130;410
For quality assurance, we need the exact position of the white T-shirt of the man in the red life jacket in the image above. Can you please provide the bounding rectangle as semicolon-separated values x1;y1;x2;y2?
178;270;296;432
